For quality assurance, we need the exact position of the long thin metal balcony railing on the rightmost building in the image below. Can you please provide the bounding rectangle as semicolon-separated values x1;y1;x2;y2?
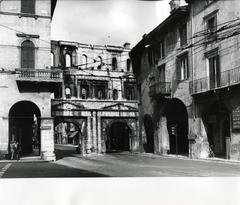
190;67;240;94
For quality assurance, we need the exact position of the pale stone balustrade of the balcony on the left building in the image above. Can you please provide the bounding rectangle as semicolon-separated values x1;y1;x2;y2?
16;69;63;82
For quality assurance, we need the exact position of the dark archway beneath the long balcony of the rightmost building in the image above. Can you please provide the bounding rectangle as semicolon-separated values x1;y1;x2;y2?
203;102;230;158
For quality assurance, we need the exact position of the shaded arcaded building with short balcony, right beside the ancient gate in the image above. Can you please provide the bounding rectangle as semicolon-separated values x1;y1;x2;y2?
130;1;192;154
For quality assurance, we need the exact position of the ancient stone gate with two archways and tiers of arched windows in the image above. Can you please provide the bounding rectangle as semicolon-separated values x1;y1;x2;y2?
52;41;139;154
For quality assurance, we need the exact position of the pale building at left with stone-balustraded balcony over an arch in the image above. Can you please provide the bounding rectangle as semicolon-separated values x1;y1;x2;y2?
0;0;62;160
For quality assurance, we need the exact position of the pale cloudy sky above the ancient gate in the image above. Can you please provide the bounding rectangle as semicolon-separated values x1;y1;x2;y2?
52;0;170;47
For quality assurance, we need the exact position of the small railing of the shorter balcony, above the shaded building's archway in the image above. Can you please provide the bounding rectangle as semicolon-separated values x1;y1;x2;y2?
149;82;172;97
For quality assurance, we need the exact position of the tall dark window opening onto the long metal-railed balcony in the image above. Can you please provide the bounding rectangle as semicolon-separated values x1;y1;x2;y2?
208;55;220;89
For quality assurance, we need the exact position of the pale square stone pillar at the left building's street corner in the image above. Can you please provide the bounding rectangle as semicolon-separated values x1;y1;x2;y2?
40;117;56;161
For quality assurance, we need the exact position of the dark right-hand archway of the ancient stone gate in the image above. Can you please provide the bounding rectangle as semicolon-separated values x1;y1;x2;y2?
106;121;131;152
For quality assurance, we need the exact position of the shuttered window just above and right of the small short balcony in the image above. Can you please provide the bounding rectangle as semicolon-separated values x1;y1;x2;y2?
177;54;189;81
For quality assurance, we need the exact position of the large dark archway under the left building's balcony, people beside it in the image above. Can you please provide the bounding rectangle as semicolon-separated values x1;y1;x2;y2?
9;101;41;156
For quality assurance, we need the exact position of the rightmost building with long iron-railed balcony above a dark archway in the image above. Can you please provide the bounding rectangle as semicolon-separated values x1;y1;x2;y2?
187;0;240;160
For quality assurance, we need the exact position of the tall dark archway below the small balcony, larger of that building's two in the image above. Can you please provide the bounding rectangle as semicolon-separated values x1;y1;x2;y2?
165;98;189;155
